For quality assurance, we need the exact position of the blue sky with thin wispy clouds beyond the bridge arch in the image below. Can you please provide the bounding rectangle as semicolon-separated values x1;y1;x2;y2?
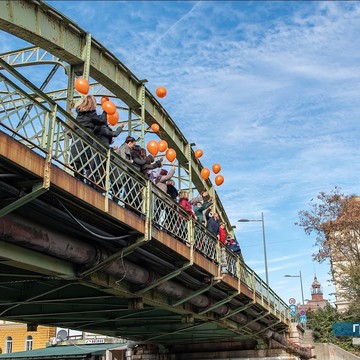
4;1;360;302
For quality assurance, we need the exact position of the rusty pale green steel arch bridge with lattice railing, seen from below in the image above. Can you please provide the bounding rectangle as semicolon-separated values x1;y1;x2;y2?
0;0;310;358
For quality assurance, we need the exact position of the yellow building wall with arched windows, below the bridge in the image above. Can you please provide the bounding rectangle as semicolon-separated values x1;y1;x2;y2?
0;322;56;354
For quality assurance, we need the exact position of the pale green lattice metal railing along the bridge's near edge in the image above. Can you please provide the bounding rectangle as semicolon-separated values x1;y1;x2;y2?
0;63;290;319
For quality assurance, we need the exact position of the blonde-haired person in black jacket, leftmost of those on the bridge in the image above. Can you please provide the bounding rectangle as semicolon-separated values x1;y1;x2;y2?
70;95;107;184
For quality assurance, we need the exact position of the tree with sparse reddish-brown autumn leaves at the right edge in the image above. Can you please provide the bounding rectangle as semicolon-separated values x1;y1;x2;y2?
296;187;360;319
